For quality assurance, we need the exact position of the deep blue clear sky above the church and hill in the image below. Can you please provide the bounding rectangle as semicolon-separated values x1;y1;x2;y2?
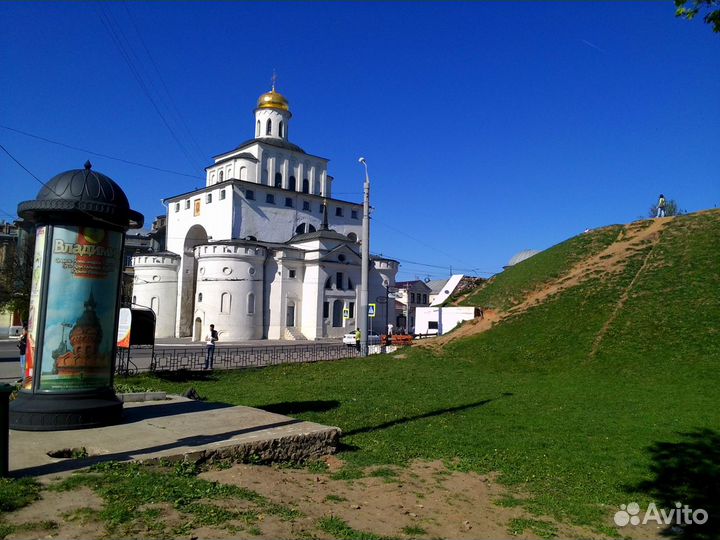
0;1;720;279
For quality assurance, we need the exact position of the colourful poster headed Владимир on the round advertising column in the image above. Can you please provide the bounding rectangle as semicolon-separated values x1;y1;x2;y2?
37;226;122;393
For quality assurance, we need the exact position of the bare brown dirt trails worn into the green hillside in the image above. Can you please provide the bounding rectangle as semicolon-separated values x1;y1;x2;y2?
413;217;674;351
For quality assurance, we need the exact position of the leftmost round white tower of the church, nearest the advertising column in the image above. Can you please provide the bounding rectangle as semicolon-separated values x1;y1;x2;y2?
132;254;180;338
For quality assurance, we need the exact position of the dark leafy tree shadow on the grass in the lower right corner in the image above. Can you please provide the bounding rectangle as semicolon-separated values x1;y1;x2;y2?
635;429;720;540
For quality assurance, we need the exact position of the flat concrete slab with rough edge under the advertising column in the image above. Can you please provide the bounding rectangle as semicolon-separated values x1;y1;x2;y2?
10;396;340;477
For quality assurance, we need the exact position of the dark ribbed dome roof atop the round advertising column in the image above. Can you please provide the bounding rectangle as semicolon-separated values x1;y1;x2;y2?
18;161;145;229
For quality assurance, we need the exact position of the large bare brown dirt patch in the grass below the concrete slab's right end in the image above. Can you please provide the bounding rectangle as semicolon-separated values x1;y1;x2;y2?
202;461;597;539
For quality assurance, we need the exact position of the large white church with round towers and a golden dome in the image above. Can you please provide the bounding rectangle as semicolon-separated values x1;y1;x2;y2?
132;85;399;341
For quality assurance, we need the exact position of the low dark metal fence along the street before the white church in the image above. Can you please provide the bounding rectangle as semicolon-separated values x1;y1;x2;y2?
116;343;366;375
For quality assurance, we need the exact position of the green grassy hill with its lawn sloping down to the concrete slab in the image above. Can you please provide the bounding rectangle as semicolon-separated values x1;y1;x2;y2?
131;211;720;538
